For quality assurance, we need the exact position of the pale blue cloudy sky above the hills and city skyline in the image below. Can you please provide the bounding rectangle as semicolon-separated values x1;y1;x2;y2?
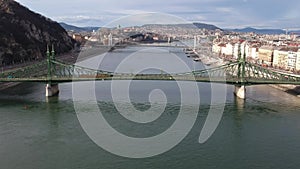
16;0;300;29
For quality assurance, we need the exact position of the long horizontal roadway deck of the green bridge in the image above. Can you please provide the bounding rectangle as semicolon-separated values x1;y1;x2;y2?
0;73;300;86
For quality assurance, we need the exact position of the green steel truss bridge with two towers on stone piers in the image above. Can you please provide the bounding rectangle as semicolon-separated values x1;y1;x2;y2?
0;48;300;98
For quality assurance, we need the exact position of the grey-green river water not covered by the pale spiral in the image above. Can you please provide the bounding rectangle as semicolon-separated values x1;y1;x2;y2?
0;47;300;169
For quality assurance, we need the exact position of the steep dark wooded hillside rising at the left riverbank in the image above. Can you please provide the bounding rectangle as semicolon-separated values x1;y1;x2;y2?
0;0;74;65
